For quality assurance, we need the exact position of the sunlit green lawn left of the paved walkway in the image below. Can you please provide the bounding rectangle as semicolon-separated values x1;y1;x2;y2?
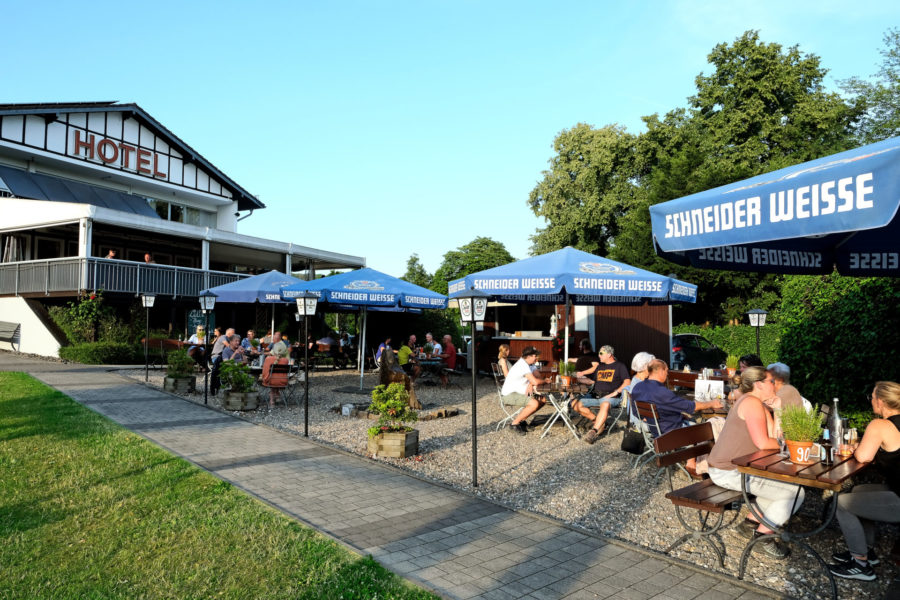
0;373;434;599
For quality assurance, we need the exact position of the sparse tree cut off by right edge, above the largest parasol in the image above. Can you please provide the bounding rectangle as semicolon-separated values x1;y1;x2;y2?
841;28;900;144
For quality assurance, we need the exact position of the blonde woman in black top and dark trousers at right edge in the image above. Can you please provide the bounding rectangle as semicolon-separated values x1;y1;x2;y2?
829;381;900;581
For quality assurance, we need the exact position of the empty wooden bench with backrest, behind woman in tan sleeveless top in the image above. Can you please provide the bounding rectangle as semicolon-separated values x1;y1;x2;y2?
653;423;743;567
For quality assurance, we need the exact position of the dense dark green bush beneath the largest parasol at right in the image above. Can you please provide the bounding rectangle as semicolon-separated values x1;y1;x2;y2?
779;274;900;414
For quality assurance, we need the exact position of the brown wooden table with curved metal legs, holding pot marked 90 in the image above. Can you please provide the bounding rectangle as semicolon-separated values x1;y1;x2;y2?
731;450;869;599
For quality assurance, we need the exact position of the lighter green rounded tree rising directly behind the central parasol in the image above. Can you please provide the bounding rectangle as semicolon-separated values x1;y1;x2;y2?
528;123;640;256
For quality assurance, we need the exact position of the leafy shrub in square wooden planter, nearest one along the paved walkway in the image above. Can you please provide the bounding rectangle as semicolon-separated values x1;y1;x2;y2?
368;383;419;458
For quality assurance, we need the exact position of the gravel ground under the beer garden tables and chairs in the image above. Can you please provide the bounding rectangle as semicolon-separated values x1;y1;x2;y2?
123;369;898;598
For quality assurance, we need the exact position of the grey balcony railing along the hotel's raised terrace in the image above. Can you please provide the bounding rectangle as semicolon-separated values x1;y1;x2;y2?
0;258;247;297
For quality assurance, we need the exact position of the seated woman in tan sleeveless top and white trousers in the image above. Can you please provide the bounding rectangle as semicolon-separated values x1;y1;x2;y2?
708;367;803;559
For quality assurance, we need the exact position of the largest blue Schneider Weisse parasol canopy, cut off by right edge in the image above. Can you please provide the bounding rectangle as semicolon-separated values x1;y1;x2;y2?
650;138;900;277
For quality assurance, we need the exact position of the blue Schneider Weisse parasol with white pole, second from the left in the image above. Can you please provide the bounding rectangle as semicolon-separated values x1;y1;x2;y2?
281;267;447;389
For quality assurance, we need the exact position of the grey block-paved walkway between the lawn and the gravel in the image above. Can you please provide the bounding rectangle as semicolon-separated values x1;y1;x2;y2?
0;352;779;600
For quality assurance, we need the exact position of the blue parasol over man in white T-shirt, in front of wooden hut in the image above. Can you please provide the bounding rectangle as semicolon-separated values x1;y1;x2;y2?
449;247;697;360
